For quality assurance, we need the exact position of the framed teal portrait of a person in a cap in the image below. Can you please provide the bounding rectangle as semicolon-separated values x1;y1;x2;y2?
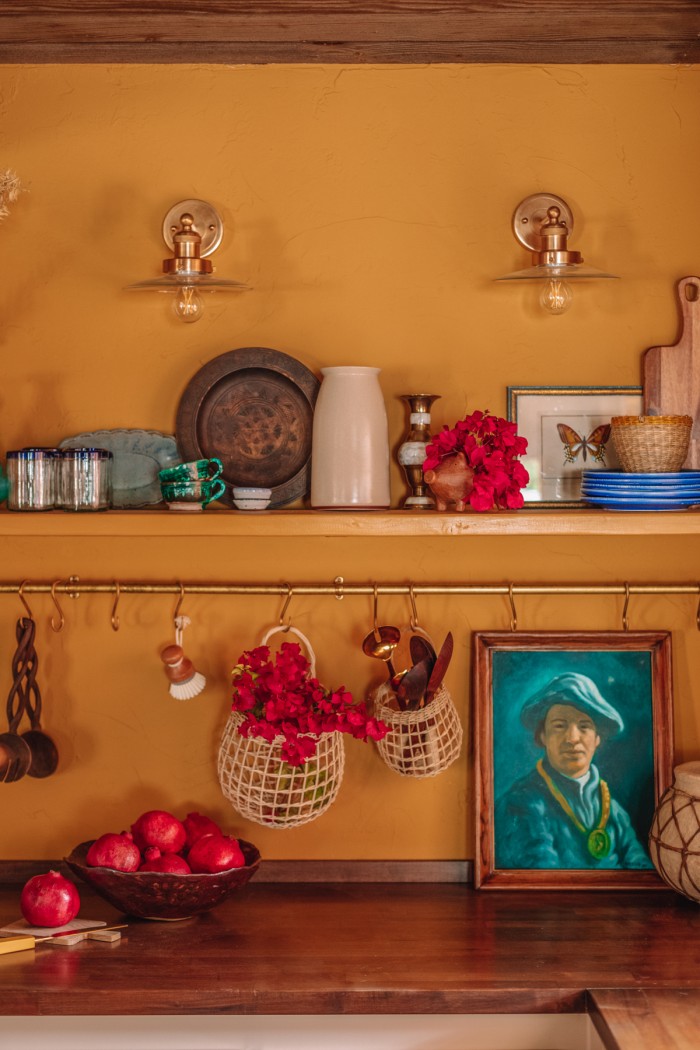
473;631;673;889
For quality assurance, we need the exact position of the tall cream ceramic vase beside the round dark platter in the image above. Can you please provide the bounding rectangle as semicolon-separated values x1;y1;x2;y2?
311;365;390;510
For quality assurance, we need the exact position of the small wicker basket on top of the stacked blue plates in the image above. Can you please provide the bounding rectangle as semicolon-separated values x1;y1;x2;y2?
612;416;693;474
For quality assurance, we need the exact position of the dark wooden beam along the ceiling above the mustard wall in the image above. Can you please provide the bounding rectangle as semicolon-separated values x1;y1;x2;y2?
0;0;700;64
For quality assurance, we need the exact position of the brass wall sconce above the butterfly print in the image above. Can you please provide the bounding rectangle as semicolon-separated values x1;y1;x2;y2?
495;193;617;315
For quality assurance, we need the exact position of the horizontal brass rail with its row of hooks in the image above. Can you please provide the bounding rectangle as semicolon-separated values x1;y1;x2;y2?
0;575;700;636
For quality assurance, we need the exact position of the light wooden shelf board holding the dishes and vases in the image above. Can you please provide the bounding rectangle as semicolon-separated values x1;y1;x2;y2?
0;508;700;540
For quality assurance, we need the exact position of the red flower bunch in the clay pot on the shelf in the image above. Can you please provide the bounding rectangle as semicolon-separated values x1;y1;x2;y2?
423;412;530;510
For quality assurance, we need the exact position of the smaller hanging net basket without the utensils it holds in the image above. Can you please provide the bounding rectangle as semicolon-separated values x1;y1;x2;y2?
373;683;463;778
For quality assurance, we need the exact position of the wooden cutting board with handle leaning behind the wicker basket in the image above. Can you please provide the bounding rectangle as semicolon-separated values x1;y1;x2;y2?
642;277;700;470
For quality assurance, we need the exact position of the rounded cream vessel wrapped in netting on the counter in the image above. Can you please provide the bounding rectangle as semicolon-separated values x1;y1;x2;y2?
649;762;700;902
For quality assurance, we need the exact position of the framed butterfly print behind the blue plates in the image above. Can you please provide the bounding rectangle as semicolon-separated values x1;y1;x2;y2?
508;386;642;506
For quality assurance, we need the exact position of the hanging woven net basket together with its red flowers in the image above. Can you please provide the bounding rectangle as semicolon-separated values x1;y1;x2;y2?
217;627;386;828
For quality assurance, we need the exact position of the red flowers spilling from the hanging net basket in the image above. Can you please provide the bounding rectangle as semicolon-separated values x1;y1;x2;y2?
232;642;388;765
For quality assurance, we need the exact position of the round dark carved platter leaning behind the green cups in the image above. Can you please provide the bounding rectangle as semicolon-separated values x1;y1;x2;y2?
175;347;320;507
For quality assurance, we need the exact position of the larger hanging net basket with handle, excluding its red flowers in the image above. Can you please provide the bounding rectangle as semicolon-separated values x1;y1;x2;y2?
217;627;345;828
